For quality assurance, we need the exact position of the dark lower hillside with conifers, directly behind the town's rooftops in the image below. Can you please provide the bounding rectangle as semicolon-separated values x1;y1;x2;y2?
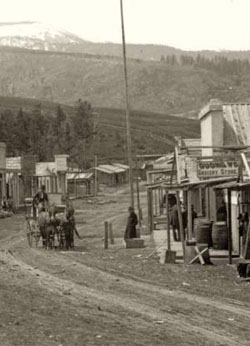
0;97;199;168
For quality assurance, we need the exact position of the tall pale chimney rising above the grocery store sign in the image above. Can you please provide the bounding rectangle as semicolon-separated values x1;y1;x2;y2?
199;99;224;156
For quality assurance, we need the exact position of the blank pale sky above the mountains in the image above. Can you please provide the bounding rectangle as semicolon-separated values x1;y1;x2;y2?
0;0;250;50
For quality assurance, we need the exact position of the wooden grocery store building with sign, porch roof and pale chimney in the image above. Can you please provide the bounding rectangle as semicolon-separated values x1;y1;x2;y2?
148;100;250;255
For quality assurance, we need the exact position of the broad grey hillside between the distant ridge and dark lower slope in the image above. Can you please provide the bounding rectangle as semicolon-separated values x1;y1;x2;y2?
0;24;250;118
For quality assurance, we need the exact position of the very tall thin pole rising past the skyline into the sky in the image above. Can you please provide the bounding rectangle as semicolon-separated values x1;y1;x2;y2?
120;0;134;207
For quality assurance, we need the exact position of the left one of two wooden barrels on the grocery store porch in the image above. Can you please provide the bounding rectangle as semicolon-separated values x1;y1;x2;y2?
194;218;213;246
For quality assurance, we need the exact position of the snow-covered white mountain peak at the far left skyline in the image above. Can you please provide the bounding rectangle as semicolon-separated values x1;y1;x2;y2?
0;22;84;51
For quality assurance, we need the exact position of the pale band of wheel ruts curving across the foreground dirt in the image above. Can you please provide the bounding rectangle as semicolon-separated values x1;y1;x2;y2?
0;249;250;345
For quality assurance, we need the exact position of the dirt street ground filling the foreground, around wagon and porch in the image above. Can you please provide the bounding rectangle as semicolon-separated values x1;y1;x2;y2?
0;188;250;346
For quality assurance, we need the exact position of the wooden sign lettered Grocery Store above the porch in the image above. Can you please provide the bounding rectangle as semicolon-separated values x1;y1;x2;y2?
197;160;239;178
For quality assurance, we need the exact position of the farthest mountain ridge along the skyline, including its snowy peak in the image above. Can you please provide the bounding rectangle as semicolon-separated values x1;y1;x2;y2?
0;21;250;61
